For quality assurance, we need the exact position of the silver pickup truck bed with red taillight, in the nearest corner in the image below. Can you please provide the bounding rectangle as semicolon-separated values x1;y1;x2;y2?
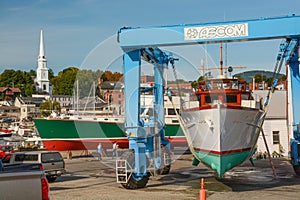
0;160;50;200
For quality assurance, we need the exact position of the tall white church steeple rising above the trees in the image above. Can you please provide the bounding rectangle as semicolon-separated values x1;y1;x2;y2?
35;30;50;94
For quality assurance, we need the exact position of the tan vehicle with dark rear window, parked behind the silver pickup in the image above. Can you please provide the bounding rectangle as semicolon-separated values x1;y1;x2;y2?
2;151;66;182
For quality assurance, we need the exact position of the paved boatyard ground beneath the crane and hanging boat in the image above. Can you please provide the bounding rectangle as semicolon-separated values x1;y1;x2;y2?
50;152;300;200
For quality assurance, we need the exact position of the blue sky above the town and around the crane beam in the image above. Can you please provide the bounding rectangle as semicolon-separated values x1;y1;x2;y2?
0;0;300;80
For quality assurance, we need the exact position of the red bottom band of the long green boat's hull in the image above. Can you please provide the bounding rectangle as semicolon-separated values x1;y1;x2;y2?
43;138;187;151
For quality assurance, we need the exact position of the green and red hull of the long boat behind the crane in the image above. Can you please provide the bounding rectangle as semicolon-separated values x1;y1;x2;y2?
34;119;187;151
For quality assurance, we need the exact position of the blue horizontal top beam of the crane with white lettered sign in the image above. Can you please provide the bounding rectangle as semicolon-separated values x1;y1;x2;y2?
118;15;300;51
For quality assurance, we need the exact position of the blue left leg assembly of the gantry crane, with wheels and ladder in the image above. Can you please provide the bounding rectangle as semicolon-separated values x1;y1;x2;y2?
116;47;175;189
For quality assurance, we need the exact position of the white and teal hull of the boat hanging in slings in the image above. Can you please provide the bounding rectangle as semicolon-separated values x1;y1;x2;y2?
181;105;263;177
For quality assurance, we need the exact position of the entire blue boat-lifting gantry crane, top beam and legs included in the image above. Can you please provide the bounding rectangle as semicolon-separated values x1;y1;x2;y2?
117;15;300;189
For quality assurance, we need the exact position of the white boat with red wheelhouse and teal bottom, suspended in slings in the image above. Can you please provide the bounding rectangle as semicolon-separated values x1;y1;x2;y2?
181;77;264;177
